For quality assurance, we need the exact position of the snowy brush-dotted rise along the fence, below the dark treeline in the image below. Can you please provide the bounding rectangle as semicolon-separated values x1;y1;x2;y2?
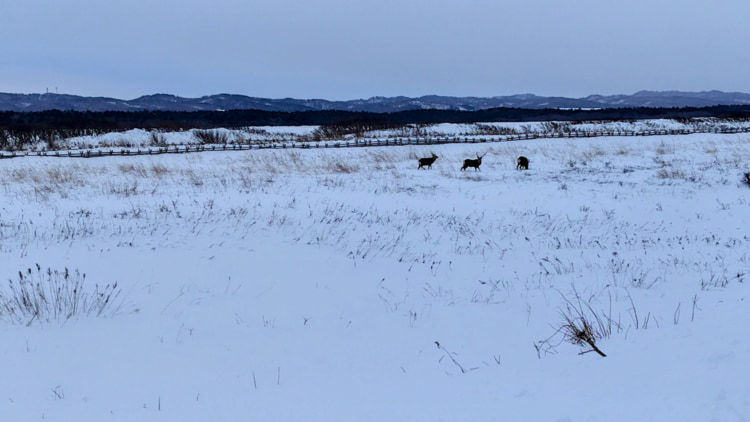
0;118;750;157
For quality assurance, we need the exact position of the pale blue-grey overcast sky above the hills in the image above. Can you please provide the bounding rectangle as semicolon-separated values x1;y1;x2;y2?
0;0;750;100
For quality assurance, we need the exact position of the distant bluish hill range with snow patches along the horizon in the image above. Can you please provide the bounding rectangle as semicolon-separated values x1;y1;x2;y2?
0;91;750;113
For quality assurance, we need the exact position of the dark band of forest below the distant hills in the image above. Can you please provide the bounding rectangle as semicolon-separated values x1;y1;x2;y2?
0;105;750;149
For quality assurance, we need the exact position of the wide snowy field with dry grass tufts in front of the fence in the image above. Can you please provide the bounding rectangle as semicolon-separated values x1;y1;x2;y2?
0;120;750;422
